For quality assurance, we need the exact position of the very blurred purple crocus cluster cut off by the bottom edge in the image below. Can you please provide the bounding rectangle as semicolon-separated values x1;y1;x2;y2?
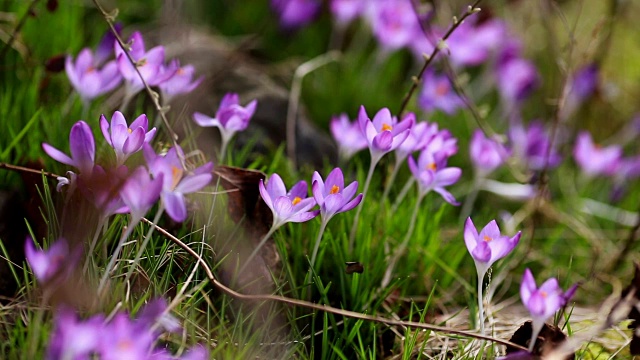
46;299;208;360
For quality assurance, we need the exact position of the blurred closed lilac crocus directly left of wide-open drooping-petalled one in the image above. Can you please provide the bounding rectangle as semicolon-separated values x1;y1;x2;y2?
120;166;163;219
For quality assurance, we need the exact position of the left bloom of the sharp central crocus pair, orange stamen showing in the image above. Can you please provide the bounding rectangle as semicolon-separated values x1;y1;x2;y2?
258;174;320;228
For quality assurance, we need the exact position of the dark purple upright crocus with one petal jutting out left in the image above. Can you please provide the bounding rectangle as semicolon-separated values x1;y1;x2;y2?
42;120;96;175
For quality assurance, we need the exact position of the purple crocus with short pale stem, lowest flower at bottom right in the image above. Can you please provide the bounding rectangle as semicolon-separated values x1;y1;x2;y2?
520;269;577;351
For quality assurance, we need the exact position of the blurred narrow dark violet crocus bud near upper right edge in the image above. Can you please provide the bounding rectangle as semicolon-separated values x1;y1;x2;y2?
559;64;600;120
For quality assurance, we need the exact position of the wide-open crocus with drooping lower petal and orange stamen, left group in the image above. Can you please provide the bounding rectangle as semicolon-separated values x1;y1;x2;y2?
143;144;213;222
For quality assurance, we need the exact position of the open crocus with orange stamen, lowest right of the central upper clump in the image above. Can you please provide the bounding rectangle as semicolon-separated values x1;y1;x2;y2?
409;150;462;206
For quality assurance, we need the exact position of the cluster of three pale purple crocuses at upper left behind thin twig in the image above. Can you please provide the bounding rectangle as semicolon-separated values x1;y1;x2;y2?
65;31;202;106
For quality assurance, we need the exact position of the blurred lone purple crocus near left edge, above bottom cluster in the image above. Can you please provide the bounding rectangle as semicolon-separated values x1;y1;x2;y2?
24;236;73;284
